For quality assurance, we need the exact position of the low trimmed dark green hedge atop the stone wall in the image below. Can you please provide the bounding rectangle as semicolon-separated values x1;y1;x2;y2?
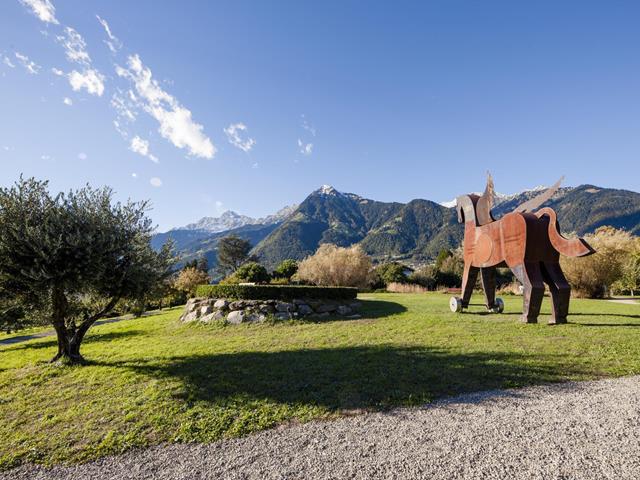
196;285;358;301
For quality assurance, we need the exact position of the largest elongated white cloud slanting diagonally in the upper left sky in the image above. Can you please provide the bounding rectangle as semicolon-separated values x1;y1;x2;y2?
116;55;216;158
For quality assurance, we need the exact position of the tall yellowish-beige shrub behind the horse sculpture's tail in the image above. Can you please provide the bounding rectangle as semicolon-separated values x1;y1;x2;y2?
560;227;638;298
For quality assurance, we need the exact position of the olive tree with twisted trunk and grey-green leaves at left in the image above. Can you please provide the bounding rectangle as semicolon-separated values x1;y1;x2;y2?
0;177;171;363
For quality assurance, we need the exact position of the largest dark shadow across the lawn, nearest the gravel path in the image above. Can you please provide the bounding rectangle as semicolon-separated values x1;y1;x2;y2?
106;346;582;410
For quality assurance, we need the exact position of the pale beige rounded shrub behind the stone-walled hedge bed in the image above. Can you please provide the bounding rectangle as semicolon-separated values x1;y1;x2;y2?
296;243;373;288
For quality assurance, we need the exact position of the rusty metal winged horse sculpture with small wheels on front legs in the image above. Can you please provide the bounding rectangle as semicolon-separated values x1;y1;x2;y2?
450;175;594;324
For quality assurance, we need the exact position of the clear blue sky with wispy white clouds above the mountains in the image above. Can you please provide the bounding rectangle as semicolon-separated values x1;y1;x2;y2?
0;0;640;230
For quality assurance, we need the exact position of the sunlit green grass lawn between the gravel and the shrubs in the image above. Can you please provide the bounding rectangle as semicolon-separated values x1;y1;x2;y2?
0;294;640;469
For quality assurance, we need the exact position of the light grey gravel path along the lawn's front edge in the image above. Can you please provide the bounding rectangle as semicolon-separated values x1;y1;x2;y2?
5;377;640;480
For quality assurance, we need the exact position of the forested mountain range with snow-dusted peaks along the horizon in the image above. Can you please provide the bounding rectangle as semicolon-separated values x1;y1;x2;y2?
152;185;640;271
